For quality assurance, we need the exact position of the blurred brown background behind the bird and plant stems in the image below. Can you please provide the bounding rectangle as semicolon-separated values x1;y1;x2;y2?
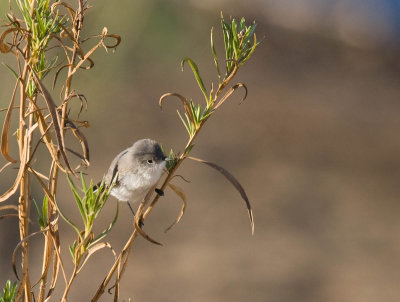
0;0;400;302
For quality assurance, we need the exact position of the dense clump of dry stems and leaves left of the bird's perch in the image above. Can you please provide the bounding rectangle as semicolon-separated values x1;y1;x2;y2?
0;0;121;301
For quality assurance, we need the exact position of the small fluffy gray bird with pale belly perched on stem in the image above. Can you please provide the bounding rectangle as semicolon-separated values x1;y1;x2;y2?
105;138;167;206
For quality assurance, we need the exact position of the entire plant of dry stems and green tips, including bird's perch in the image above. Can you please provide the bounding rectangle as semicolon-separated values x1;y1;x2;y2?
0;0;259;301
